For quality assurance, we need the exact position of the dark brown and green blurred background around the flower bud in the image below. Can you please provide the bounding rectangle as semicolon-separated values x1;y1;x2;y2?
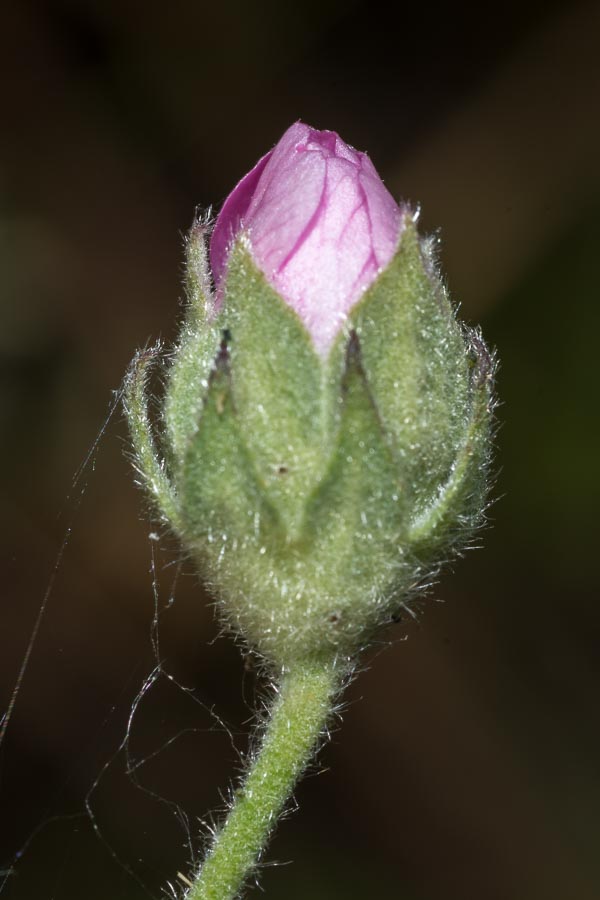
0;0;600;900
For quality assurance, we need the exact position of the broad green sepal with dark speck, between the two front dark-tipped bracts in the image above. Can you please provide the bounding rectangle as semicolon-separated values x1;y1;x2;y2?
219;239;323;540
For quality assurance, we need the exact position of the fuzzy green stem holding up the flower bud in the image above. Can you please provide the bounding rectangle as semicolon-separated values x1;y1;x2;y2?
186;662;340;900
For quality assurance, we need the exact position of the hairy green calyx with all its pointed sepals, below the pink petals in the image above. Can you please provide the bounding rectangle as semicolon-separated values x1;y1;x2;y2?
125;218;492;668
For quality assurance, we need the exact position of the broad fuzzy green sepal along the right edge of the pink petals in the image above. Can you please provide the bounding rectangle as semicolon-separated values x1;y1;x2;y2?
348;214;470;516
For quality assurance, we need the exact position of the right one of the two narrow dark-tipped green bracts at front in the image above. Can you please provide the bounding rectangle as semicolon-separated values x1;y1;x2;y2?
304;332;408;652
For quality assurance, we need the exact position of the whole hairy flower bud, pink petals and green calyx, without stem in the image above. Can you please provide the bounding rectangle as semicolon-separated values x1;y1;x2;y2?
127;124;493;667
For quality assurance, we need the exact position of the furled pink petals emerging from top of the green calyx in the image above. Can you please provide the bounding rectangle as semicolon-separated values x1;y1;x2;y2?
210;122;402;354
